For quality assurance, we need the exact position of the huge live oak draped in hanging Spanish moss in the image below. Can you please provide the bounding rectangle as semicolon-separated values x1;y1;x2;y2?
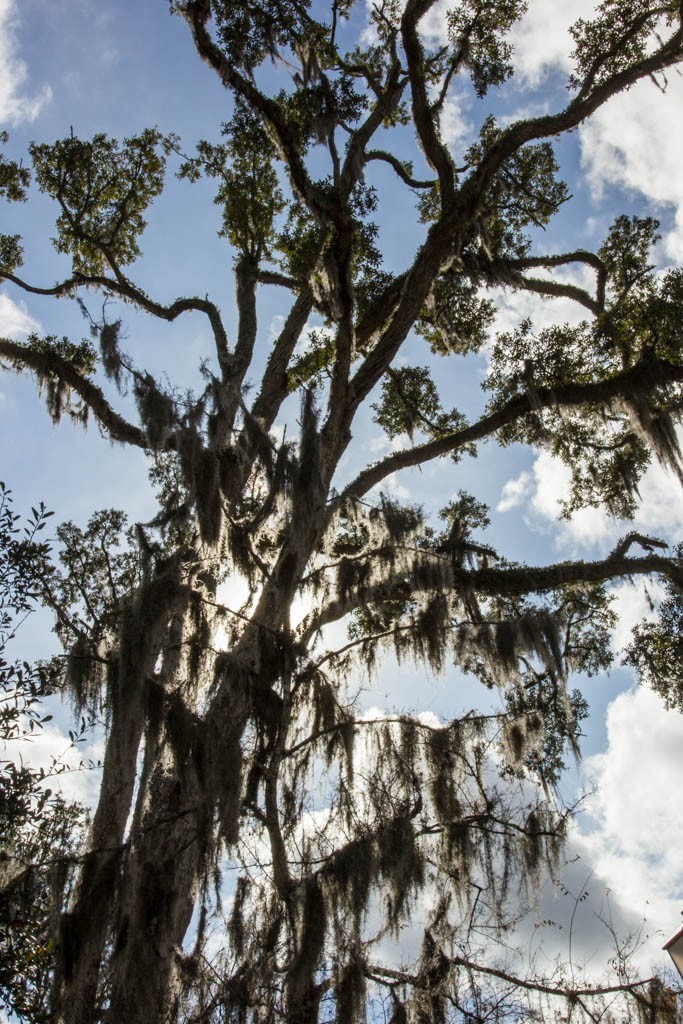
0;0;683;1024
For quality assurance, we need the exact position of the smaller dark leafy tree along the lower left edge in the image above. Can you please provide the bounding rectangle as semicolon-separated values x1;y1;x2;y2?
0;481;82;1024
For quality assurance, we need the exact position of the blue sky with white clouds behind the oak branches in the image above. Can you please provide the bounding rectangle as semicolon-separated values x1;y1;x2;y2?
0;0;683;987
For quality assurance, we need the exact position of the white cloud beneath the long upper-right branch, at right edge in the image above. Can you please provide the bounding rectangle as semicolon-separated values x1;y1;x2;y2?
581;72;683;262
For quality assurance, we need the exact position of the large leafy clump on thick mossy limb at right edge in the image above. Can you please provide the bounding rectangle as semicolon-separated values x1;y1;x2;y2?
484;217;683;518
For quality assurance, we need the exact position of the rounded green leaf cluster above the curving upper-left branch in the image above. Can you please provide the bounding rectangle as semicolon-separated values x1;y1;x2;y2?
30;128;177;275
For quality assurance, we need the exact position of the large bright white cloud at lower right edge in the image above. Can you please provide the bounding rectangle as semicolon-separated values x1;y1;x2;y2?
577;687;683;955
